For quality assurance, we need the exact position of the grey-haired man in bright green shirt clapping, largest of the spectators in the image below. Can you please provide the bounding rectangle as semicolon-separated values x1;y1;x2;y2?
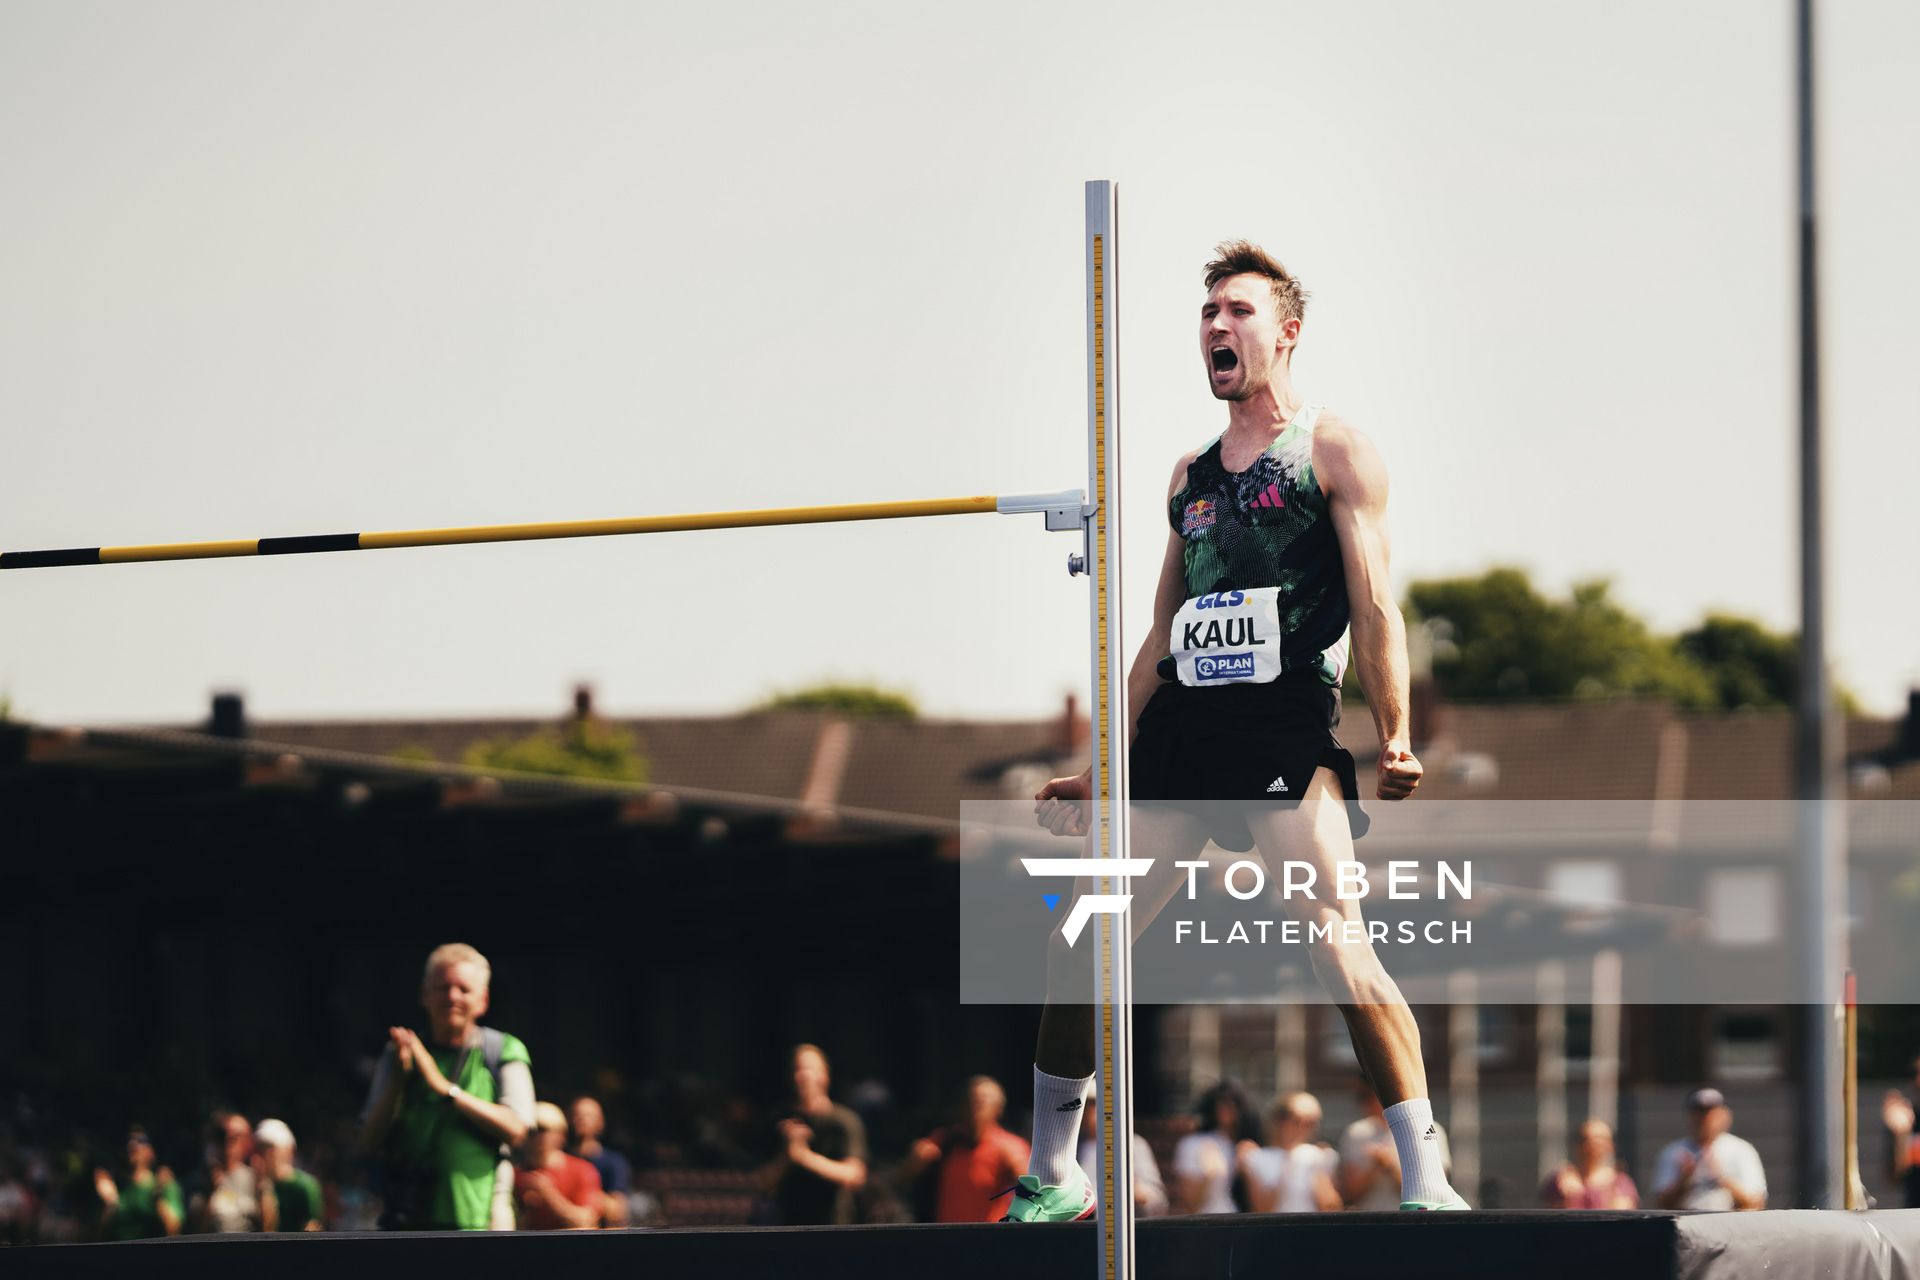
359;942;534;1230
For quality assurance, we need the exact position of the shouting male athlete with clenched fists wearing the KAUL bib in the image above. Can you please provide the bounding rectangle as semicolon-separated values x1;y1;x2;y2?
1008;240;1467;1222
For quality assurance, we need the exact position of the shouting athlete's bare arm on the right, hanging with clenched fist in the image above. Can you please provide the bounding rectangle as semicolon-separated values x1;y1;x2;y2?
1313;415;1421;800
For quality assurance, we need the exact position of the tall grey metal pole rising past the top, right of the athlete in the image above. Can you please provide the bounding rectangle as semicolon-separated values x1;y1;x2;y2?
1793;0;1847;1209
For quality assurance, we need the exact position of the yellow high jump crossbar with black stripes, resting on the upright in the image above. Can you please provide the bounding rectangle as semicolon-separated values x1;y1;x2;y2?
0;489;1083;570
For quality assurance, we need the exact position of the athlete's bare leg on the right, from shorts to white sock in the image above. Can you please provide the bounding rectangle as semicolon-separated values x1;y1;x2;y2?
1248;768;1427;1107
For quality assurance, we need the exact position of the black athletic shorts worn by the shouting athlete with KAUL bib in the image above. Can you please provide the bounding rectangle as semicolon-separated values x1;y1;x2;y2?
1127;670;1369;854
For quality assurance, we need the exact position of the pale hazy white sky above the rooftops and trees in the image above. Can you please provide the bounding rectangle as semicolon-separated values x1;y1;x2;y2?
0;0;1920;722
